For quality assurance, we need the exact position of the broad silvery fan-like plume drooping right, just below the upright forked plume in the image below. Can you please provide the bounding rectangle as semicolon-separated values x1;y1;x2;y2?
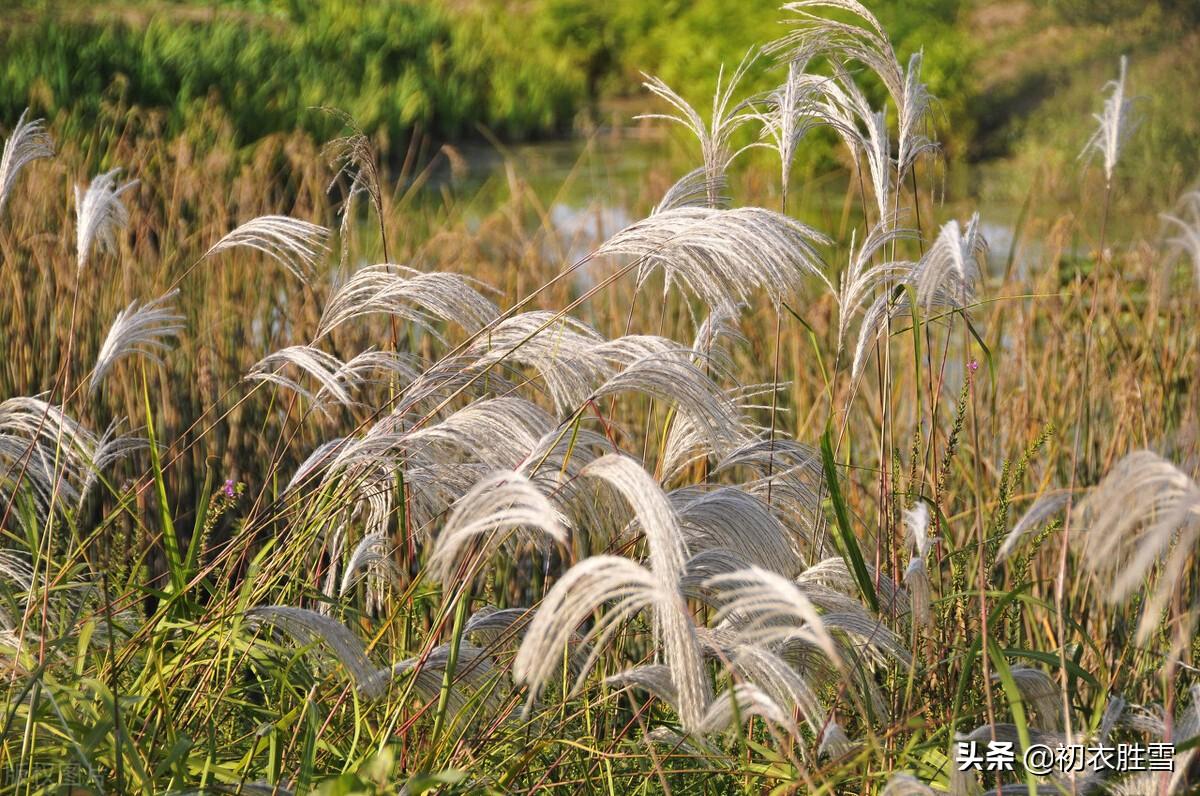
596;207;833;315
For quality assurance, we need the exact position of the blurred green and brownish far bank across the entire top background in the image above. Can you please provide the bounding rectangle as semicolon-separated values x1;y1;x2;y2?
0;0;1200;193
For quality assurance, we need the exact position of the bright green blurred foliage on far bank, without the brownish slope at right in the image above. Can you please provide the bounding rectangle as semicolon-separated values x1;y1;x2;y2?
0;0;970;151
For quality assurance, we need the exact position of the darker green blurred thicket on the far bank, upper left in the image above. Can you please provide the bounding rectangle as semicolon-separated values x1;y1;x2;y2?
0;0;581;142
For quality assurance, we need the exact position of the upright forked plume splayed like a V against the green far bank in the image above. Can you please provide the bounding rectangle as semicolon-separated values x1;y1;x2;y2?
637;53;754;208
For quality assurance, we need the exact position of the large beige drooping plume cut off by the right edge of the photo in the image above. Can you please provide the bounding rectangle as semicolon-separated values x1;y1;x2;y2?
1072;450;1200;644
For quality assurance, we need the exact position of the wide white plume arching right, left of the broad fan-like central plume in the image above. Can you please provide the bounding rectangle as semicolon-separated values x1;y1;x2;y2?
317;263;499;340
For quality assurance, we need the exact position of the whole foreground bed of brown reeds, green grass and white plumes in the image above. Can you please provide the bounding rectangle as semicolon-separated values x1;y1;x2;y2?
0;0;1200;794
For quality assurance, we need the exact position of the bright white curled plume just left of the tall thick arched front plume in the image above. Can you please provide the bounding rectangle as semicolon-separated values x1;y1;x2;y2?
428;471;566;586
